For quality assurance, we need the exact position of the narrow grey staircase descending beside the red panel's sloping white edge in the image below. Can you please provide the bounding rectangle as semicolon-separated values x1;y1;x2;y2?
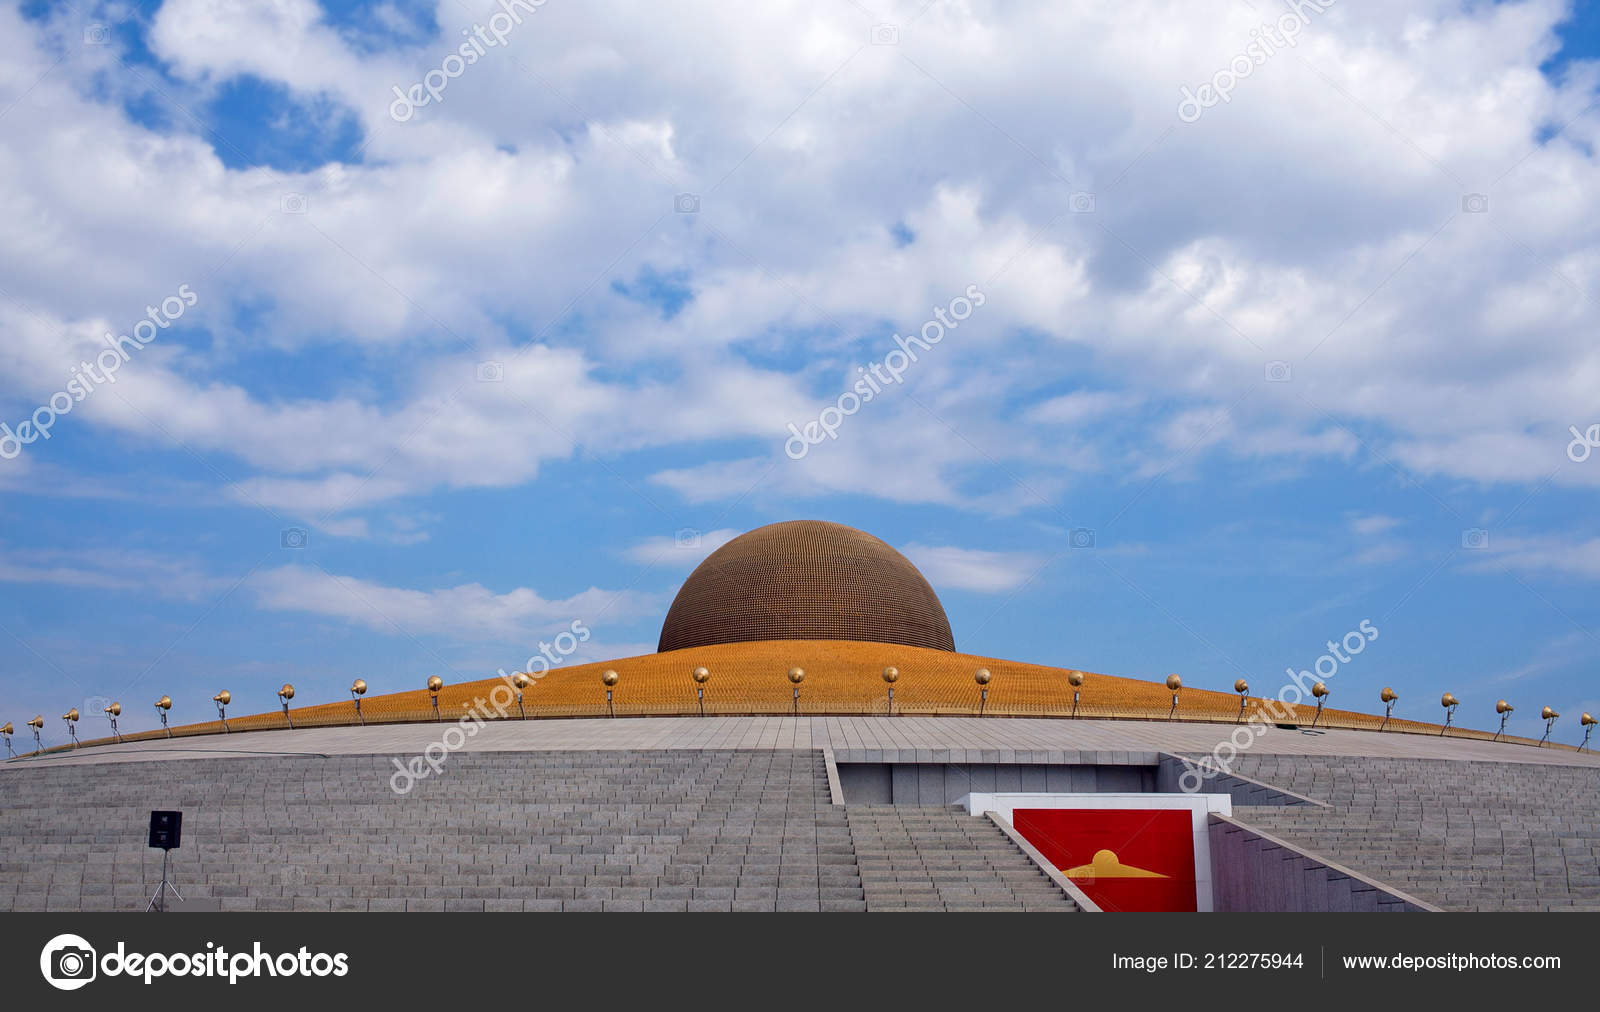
845;805;1078;911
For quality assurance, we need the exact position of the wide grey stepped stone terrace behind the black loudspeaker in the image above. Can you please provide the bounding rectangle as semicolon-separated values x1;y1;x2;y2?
0;749;866;911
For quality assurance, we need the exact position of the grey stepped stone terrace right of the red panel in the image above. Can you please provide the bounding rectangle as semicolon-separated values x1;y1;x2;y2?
1234;756;1600;910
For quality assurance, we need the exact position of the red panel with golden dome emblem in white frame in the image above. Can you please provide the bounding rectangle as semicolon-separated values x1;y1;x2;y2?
1011;809;1195;911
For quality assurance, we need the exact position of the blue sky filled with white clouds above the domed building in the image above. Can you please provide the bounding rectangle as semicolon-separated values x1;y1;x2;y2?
0;0;1600;741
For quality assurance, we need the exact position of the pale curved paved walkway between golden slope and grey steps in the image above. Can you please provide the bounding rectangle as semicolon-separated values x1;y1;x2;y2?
0;717;1600;772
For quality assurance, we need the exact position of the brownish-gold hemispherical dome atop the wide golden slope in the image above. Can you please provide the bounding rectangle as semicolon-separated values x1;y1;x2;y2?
658;520;955;653
